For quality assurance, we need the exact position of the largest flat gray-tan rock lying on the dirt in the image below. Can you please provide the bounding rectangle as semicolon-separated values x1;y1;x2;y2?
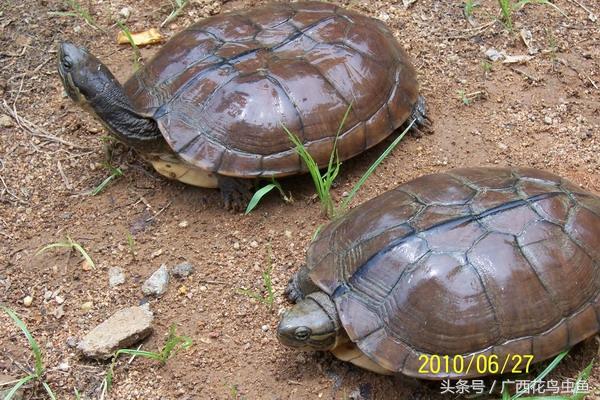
77;307;154;360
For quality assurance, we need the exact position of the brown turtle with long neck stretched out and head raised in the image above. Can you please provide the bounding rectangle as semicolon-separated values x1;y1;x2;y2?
58;2;425;208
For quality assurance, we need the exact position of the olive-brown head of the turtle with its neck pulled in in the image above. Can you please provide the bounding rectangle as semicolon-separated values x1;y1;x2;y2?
277;292;342;351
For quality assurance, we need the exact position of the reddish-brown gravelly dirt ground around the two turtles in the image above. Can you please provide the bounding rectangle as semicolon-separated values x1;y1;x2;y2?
0;0;600;399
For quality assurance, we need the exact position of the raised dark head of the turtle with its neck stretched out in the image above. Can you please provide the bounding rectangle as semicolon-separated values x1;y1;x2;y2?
58;42;119;105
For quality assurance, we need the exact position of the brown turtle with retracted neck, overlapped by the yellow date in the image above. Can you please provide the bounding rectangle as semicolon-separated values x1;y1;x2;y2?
278;168;600;379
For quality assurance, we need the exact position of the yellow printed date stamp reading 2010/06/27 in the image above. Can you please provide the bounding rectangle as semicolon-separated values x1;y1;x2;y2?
418;354;534;375
